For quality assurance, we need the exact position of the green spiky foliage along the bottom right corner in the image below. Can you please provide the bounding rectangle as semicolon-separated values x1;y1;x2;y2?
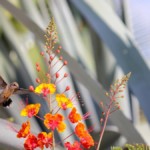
111;144;150;150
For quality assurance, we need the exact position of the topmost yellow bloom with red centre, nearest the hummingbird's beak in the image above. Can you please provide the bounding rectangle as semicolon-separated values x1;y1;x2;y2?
34;83;56;97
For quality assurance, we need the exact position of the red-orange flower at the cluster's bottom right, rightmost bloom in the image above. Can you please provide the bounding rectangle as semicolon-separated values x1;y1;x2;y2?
80;132;94;149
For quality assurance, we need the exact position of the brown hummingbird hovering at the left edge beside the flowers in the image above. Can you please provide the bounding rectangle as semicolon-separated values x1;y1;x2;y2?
0;76;31;107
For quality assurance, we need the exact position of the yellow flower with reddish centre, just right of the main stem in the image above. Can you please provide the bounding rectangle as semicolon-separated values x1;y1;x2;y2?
56;94;73;110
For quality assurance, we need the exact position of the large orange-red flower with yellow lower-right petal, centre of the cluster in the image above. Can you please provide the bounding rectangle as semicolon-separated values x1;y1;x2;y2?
44;113;66;132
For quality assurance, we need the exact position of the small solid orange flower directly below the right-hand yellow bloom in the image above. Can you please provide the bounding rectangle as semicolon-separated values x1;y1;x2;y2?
68;107;81;123
